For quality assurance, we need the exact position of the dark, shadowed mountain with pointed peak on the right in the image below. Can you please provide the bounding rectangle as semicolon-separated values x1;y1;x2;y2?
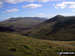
23;15;75;41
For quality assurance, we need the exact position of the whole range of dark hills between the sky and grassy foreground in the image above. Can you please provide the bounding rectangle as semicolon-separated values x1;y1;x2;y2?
0;15;75;41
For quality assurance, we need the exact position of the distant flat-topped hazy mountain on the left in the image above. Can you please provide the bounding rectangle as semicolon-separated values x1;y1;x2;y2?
0;17;46;32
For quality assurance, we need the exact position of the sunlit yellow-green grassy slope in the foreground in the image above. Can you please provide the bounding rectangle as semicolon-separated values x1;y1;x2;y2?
0;33;75;56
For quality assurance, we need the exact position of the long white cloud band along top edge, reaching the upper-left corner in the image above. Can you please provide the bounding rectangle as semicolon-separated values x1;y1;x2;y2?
0;0;61;7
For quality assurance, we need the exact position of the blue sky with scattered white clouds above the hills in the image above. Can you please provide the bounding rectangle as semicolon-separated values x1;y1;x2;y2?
0;0;75;21
